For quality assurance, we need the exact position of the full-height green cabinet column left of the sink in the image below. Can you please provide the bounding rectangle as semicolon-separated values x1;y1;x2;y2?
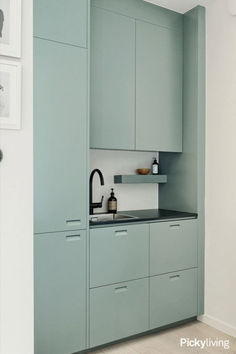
34;0;89;354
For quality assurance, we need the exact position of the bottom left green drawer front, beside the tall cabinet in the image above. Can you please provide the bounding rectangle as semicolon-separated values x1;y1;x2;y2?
90;279;148;347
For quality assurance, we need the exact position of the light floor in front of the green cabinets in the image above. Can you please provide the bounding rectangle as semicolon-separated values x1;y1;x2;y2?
91;321;236;354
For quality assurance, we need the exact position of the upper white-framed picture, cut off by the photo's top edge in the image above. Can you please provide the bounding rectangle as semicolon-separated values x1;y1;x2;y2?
0;0;21;58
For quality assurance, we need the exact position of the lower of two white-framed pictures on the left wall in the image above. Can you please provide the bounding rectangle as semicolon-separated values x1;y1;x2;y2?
0;60;21;129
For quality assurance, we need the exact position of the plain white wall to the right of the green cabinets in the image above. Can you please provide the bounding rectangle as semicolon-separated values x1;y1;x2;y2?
204;0;236;336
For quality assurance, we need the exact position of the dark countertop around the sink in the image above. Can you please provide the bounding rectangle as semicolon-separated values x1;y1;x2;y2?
90;209;197;228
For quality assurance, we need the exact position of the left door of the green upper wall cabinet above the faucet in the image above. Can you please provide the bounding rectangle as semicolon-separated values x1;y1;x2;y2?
90;7;135;150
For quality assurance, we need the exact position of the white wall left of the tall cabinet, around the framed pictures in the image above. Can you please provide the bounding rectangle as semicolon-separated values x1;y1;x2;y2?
0;0;33;354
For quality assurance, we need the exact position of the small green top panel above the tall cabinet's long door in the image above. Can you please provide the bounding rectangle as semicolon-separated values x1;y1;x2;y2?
34;0;88;47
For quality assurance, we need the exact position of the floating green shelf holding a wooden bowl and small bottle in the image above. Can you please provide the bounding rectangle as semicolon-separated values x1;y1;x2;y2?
114;175;167;184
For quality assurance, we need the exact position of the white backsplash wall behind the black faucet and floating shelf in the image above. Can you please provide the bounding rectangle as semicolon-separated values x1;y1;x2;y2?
90;150;158;213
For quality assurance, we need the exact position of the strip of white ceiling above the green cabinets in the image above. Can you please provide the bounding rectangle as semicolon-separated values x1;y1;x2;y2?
144;0;208;13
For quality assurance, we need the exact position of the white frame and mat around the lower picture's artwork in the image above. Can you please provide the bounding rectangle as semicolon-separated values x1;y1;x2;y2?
0;60;21;129
